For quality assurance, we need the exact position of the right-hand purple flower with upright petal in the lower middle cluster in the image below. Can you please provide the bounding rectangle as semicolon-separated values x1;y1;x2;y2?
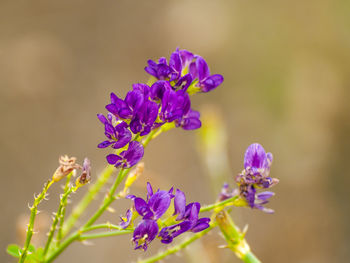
158;189;210;244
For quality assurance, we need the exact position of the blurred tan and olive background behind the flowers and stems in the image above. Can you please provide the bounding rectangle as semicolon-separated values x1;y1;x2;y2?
0;0;350;263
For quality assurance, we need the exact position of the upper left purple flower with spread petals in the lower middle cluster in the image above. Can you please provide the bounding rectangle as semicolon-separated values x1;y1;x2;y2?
134;183;173;220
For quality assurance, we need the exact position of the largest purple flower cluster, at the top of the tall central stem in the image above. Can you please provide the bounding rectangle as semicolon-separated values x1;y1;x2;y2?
98;49;223;168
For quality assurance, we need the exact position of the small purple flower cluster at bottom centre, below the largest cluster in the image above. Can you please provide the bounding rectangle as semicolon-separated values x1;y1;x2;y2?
120;183;210;250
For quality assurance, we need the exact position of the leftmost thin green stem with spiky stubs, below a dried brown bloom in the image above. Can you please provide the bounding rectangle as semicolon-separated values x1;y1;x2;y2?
18;180;54;263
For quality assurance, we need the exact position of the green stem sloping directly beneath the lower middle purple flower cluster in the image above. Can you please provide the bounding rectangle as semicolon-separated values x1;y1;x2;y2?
138;223;216;263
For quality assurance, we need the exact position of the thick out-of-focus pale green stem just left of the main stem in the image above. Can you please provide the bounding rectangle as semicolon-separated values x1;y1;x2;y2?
61;165;115;238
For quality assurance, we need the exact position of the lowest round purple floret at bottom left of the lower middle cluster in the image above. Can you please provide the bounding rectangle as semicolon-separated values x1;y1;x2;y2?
132;219;159;251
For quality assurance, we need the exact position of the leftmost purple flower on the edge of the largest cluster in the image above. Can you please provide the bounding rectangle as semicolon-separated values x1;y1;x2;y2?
97;114;132;149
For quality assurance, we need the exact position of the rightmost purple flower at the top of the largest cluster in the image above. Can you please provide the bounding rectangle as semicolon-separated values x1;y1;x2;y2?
190;56;224;92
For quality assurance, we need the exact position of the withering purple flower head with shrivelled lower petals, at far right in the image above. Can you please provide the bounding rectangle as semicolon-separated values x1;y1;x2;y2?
236;143;278;213
